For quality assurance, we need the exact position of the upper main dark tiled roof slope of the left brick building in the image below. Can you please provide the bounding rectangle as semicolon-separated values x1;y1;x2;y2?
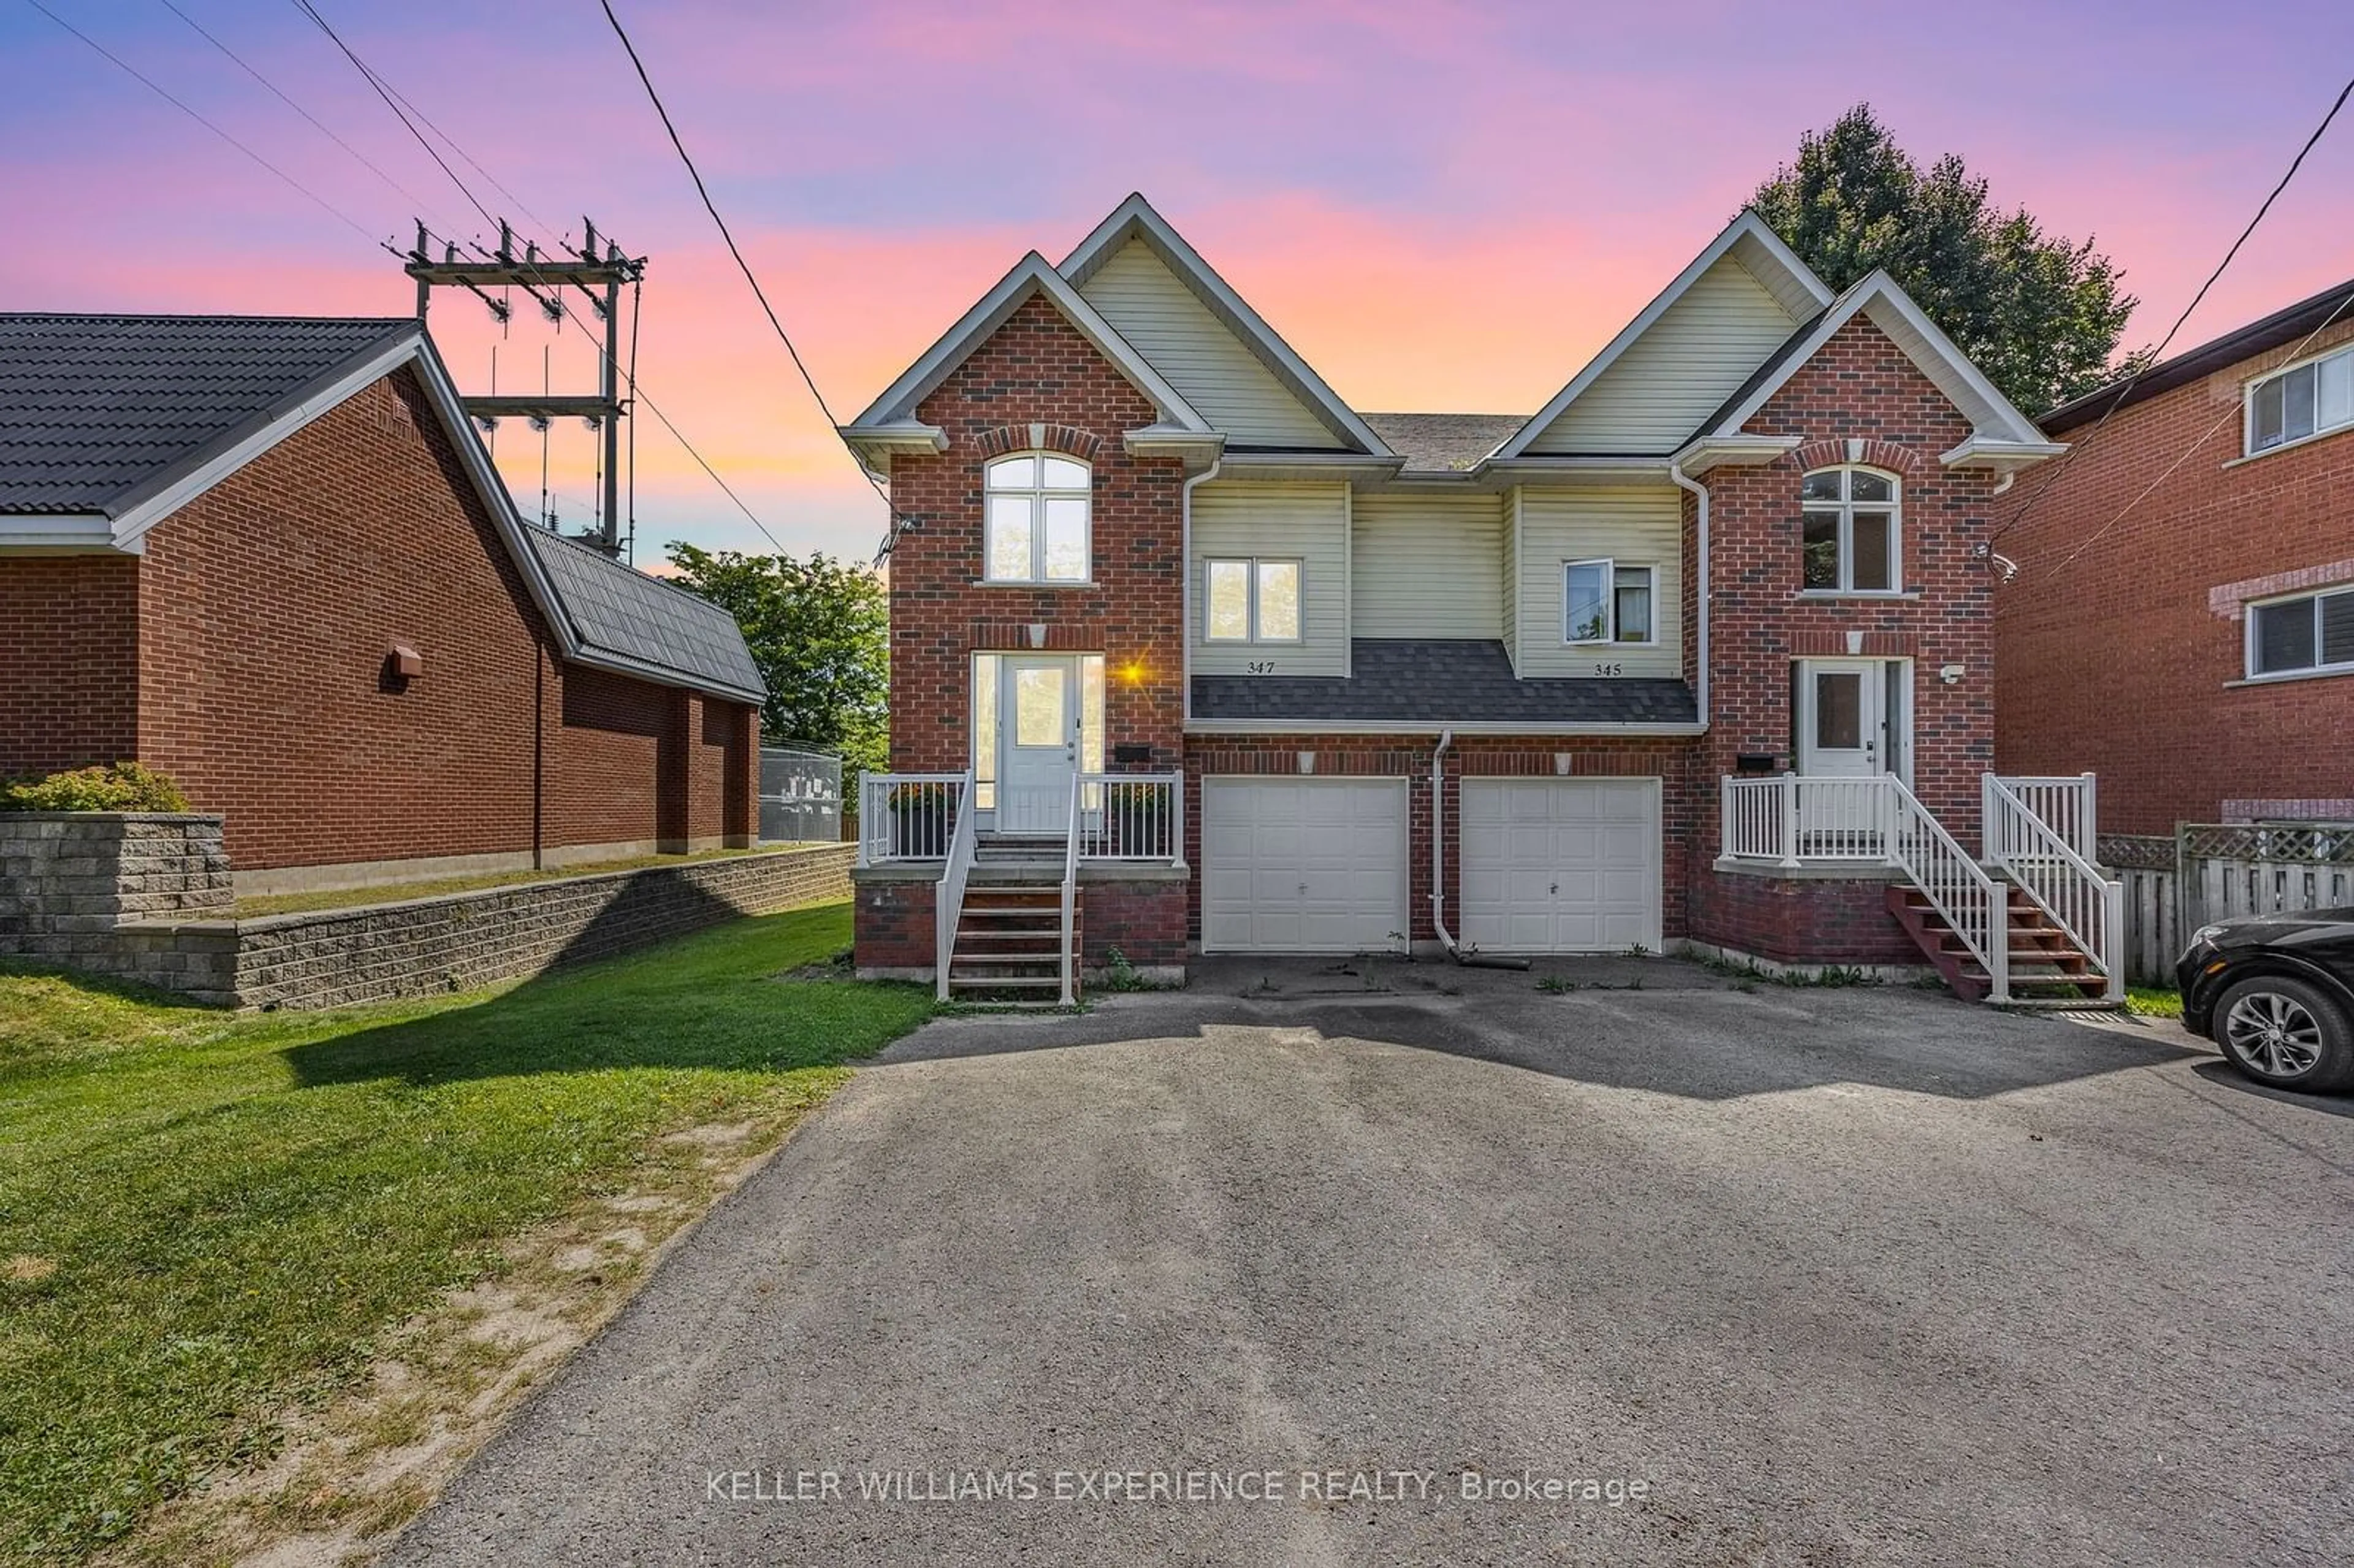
0;313;419;516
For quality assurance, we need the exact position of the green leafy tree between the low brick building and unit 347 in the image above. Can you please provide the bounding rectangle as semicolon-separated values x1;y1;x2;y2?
671;539;890;777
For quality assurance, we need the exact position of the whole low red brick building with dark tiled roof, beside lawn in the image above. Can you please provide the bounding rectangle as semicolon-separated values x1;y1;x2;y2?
0;316;763;890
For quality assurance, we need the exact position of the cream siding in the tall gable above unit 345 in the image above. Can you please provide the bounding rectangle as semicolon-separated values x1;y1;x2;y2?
1528;254;1799;454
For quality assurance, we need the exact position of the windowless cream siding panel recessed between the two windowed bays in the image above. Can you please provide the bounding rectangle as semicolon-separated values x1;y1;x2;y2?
1351;490;1511;641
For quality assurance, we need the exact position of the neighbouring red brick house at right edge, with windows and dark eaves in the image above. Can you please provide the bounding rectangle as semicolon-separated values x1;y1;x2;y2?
1994;283;2354;834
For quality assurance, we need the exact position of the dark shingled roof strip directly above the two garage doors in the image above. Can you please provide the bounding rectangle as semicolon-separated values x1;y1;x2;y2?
1194;638;1699;728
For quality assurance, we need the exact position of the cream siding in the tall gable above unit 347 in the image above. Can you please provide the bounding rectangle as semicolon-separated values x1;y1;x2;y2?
1078;240;1342;450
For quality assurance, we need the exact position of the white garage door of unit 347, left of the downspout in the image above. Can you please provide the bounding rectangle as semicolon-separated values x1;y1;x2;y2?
1200;779;1407;954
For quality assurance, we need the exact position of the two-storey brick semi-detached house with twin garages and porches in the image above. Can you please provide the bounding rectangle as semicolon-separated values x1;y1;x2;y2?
843;198;2107;994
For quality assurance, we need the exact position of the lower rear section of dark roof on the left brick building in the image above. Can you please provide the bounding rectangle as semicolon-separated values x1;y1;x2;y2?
522;527;768;702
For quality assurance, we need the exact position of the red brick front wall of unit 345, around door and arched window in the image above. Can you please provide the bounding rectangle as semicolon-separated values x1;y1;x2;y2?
1704;316;1996;843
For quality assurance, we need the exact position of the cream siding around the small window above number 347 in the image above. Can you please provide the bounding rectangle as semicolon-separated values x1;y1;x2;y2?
1186;481;1349;676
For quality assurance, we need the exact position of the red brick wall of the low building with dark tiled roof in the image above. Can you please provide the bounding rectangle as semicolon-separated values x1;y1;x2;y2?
0;370;758;871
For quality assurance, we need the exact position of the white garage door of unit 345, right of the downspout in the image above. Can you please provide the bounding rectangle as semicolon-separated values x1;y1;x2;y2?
1460;779;1659;954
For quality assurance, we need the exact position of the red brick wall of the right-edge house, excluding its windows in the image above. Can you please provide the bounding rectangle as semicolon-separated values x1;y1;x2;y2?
1994;322;2354;834
